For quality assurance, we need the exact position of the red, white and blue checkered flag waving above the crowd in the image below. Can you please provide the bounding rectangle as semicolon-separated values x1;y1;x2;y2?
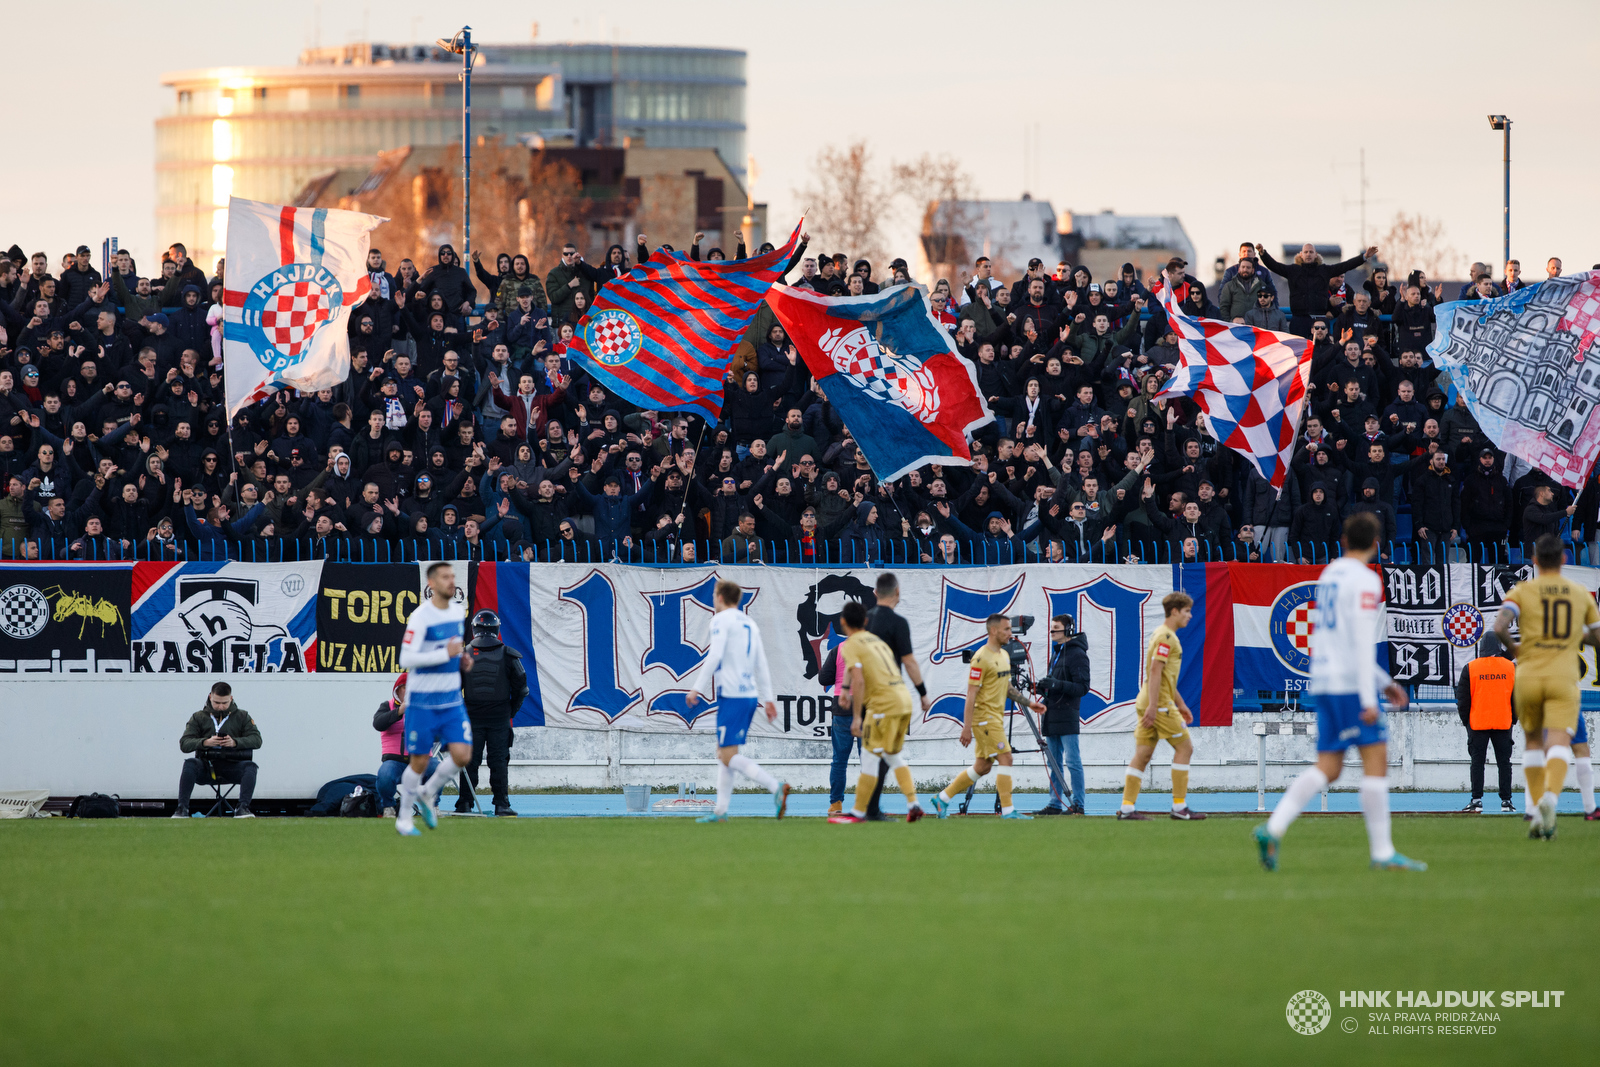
1154;278;1310;491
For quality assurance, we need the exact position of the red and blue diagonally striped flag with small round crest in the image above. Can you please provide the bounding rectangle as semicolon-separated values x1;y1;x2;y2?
566;226;800;421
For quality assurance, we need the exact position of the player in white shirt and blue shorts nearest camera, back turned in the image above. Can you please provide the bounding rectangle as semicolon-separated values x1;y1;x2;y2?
1254;512;1427;870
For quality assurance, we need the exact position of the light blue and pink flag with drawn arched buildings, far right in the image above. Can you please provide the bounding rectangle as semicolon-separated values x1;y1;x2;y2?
1427;270;1600;490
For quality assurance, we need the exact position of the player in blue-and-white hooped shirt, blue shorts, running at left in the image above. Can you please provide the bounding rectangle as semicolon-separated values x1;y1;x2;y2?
395;563;472;837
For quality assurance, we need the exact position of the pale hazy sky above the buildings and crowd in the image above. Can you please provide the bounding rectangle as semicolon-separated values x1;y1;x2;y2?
12;0;1600;277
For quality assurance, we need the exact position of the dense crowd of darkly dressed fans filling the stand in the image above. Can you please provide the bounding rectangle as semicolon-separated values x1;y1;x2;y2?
0;234;1600;566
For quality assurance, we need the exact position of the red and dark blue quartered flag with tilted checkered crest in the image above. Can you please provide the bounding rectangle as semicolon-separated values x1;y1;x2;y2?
766;285;994;482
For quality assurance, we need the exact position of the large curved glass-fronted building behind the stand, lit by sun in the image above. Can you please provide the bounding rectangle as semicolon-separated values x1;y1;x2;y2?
155;43;744;275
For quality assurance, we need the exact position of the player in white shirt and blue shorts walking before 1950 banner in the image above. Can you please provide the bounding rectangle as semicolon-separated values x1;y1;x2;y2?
686;581;789;822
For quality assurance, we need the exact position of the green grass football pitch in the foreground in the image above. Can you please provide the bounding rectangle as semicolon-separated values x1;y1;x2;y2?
0;816;1600;1067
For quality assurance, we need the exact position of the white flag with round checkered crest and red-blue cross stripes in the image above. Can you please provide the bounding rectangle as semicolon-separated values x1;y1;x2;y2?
222;197;389;418
